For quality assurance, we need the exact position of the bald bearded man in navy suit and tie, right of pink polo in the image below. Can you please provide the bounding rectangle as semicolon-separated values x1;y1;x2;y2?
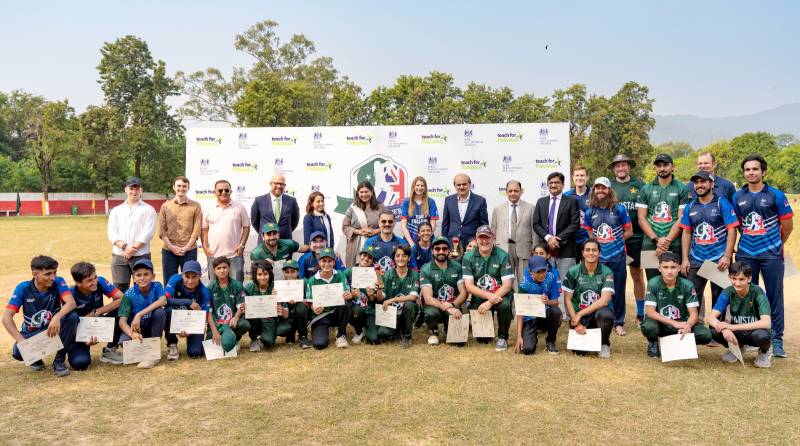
250;175;300;240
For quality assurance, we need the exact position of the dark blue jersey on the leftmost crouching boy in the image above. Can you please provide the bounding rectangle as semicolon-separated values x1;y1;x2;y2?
6;277;72;335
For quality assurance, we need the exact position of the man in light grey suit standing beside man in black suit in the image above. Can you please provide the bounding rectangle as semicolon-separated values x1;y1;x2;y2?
492;180;539;287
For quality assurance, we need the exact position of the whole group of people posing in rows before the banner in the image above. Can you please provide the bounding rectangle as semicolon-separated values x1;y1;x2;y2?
3;153;793;376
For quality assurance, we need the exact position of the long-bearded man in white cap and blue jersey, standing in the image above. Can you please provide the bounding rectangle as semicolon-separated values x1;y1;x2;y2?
583;177;633;336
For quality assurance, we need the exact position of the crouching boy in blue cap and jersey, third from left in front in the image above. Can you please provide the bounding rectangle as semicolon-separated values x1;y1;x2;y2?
119;259;167;369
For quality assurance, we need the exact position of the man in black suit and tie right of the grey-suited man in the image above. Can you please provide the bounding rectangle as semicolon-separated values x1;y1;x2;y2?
533;172;581;314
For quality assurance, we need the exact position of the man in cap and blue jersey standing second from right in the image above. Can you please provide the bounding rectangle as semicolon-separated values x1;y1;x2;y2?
680;170;739;322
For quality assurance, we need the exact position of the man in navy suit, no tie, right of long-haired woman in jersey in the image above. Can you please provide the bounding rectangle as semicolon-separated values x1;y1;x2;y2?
442;173;489;247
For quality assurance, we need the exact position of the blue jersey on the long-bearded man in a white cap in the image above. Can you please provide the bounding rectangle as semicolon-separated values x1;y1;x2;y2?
583;203;632;262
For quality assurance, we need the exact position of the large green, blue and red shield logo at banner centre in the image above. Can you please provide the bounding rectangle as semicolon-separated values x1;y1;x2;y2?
335;154;408;215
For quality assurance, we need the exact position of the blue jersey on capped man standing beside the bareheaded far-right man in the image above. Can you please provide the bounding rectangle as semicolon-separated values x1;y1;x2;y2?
680;195;739;268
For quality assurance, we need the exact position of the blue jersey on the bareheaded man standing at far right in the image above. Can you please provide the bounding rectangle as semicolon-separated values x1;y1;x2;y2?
733;183;794;259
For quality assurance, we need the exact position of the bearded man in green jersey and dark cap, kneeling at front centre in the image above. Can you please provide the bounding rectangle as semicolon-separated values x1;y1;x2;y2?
419;237;467;345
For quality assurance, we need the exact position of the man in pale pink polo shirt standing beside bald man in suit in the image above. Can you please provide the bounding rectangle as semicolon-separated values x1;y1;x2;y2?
201;180;250;282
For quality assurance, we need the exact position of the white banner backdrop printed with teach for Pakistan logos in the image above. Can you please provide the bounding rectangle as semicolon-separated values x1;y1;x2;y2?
186;123;570;253
